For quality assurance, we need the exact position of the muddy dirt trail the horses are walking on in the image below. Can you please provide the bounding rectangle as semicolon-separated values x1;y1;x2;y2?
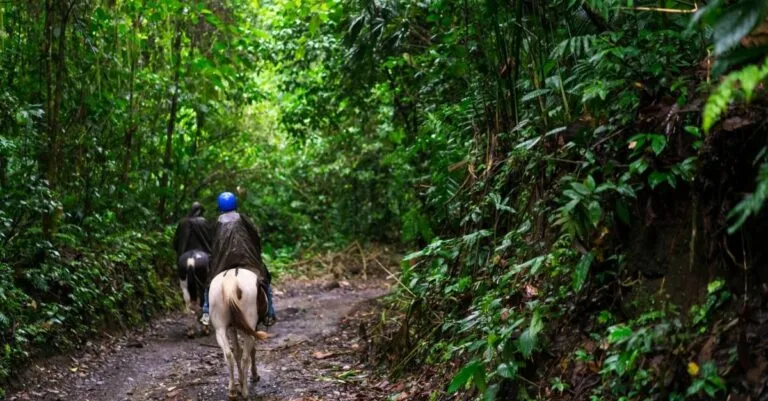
6;281;388;401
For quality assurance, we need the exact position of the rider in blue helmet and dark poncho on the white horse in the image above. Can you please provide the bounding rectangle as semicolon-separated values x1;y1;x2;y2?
201;192;276;326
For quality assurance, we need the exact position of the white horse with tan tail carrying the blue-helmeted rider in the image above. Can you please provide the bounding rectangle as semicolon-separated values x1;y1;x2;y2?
208;269;267;399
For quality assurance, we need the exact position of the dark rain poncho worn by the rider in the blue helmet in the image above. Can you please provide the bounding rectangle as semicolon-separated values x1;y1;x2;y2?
208;211;271;285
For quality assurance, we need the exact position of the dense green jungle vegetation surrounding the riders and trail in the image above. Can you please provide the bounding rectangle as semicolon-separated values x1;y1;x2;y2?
0;0;768;400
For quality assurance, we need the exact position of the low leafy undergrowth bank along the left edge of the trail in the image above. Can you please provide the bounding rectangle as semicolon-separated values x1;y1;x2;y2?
0;232;178;381
